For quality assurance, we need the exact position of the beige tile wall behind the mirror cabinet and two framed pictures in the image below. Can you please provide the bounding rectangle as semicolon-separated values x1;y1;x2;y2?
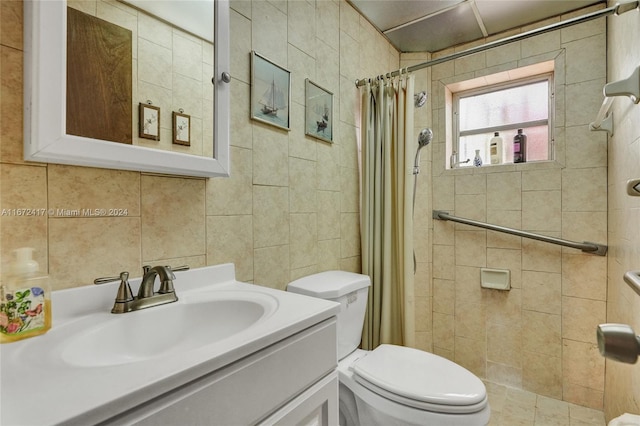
0;0;399;289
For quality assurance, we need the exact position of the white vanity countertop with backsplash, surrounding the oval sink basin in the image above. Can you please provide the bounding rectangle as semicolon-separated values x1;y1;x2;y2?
0;264;340;426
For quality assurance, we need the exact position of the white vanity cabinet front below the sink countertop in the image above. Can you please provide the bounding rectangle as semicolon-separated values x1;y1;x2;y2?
103;317;338;426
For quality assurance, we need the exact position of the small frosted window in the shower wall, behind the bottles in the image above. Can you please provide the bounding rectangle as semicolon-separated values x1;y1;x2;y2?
451;73;553;167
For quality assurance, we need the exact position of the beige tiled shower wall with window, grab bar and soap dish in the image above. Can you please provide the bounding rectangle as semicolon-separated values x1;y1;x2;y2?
402;3;607;409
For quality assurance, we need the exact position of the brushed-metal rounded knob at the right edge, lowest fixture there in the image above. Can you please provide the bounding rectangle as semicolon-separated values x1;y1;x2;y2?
597;324;640;364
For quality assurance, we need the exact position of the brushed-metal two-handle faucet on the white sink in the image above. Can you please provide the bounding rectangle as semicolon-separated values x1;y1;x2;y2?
93;265;189;314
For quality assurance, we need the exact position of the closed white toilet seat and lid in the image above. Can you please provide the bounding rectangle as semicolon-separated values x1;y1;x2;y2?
351;345;488;414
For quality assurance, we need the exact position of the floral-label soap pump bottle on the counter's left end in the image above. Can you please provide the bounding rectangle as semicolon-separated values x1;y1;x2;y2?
0;247;51;343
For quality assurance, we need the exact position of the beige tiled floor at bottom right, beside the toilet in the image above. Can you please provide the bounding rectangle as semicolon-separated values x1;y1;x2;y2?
485;382;606;426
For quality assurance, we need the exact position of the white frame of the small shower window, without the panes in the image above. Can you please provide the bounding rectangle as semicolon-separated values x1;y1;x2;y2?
451;70;555;164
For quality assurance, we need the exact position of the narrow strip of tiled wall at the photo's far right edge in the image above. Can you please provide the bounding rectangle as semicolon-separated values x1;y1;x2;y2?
604;2;640;420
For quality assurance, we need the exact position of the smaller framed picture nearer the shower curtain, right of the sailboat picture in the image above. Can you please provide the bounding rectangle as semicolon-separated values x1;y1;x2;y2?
305;78;333;143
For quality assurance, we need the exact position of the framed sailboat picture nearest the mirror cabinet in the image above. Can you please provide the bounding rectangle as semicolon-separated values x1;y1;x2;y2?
251;51;291;130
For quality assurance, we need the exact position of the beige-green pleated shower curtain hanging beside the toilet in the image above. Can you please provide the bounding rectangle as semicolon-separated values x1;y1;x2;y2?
360;74;417;349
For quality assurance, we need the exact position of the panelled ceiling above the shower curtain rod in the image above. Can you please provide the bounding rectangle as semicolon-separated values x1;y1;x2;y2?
349;0;606;52
